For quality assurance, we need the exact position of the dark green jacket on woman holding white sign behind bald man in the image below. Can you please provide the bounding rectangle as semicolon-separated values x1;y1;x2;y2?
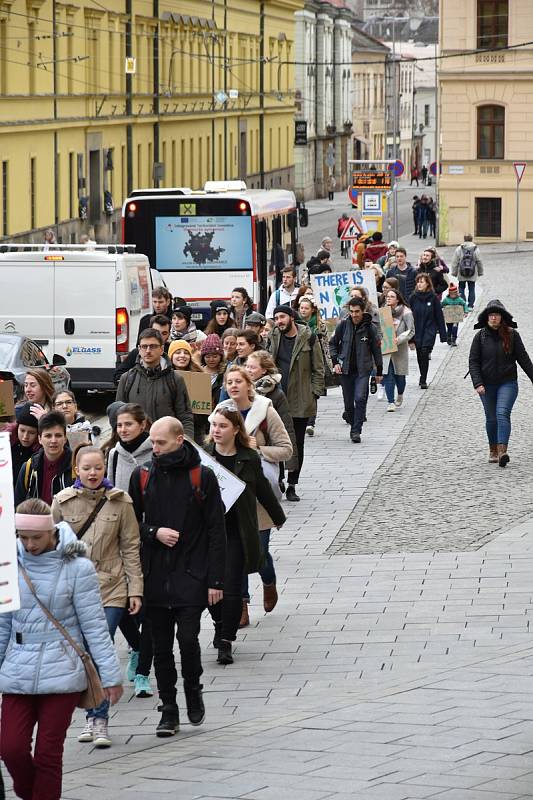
206;444;286;574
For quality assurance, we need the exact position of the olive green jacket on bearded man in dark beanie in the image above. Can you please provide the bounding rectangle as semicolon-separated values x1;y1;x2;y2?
266;325;325;418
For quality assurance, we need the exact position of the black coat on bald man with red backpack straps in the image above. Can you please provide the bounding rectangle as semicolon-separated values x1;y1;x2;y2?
129;442;226;608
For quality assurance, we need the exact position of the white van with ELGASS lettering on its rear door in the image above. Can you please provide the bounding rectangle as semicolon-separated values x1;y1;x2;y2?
0;244;157;389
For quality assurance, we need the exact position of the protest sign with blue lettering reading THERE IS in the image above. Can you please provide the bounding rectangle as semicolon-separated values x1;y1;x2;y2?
311;269;378;325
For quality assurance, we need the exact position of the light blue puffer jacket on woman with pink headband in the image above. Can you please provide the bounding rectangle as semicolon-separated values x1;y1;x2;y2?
0;522;122;694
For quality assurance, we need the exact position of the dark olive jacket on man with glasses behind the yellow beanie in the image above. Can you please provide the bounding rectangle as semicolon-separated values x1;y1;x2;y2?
117;356;194;439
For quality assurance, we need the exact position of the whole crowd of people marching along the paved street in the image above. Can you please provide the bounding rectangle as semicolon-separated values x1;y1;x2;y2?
0;212;533;800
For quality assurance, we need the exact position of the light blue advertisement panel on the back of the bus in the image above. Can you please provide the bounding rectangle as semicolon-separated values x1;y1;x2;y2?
155;216;253;272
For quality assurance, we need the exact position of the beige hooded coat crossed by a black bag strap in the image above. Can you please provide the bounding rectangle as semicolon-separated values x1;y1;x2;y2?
52;486;143;608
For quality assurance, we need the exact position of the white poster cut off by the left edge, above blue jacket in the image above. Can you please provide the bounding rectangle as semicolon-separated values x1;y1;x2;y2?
0;433;20;614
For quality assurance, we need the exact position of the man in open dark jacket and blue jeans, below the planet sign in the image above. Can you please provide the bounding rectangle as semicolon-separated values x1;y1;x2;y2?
330;297;383;443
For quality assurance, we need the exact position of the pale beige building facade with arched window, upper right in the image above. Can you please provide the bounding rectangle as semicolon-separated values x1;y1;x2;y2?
439;0;533;244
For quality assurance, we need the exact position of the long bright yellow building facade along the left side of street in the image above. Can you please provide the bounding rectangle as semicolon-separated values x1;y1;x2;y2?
0;0;303;242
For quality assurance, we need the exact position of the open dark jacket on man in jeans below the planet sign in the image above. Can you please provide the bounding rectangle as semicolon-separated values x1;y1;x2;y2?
329;311;383;378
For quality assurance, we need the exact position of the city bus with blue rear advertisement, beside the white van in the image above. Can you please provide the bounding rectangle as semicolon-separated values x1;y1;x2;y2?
122;181;307;326
